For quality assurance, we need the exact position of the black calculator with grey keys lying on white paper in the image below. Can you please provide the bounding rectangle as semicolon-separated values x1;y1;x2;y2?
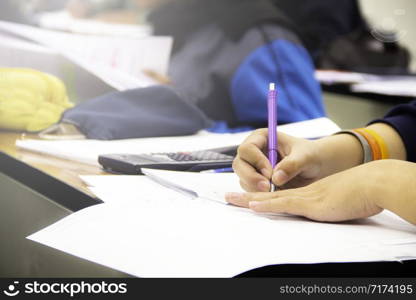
98;146;237;175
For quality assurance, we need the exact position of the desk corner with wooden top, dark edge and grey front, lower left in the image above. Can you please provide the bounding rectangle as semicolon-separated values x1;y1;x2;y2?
0;133;127;277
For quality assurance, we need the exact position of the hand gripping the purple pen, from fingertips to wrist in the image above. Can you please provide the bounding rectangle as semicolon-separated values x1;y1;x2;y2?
233;129;321;192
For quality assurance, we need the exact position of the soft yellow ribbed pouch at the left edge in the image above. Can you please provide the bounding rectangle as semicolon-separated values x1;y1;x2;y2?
0;68;73;132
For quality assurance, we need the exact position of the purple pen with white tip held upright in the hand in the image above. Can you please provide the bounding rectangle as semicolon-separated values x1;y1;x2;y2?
267;83;278;192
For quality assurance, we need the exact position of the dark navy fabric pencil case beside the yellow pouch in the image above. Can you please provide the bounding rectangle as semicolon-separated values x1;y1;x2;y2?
61;86;212;140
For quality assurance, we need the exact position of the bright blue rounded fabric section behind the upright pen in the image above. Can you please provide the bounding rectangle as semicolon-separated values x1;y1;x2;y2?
231;39;325;124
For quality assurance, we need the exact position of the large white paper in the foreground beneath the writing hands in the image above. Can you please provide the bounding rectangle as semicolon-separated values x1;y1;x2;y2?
28;174;416;277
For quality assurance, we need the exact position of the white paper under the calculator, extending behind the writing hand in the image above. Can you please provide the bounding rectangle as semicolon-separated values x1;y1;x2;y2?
16;118;340;166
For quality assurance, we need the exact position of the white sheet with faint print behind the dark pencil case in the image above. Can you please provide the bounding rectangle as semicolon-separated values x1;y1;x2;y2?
0;21;173;90
